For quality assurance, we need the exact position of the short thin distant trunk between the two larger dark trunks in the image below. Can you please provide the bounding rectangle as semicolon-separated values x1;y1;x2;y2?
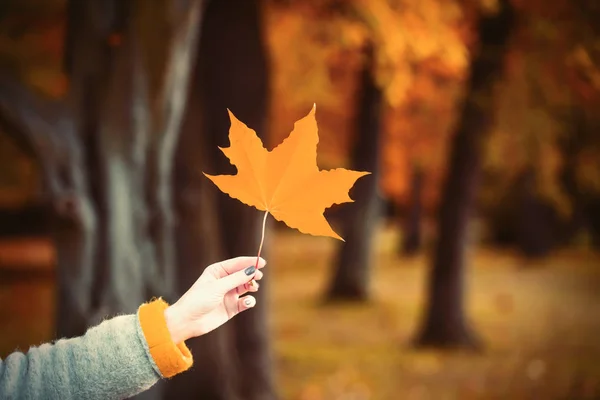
400;165;424;256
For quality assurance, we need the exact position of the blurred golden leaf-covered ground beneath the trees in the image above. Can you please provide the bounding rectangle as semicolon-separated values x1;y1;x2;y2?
0;230;600;400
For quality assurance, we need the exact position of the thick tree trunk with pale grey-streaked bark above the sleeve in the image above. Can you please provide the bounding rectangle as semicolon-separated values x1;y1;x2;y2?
59;0;201;318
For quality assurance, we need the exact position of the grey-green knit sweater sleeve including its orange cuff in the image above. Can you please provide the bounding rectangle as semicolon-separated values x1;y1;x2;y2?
0;299;193;400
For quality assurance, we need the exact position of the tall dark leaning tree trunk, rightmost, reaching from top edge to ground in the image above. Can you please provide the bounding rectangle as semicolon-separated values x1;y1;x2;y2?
416;0;514;348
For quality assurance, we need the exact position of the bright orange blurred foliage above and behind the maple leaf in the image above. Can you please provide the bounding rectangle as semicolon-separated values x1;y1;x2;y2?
265;0;470;211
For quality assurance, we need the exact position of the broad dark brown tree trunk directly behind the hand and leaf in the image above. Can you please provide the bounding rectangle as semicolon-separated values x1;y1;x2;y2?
168;0;276;400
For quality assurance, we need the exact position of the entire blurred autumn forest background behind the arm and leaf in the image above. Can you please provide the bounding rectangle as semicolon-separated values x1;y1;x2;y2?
0;0;600;400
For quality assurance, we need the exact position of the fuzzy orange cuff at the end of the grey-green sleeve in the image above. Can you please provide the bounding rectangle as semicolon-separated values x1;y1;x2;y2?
138;298;194;378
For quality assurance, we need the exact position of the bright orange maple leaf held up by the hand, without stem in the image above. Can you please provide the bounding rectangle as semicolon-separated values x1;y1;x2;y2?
204;105;370;240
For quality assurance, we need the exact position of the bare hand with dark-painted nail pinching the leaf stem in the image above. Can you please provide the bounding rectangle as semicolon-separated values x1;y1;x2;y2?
165;257;266;343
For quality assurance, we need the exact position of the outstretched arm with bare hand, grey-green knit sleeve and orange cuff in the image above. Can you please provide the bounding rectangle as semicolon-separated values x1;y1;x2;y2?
0;257;265;400
